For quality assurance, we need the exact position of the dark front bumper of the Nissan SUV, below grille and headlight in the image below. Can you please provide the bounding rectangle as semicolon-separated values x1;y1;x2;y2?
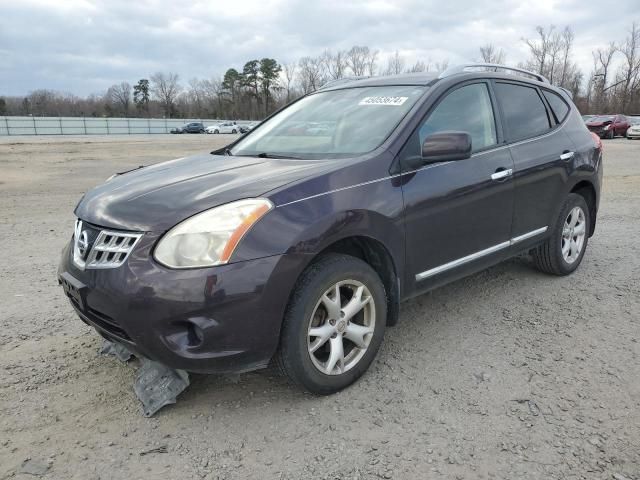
58;234;308;373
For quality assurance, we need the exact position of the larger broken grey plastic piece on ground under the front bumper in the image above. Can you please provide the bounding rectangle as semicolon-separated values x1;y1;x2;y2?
133;359;191;417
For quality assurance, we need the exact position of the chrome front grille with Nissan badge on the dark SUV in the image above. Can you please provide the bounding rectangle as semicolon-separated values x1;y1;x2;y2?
73;220;142;269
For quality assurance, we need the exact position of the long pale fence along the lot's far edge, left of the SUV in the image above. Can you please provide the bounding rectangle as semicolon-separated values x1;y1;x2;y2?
0;117;246;136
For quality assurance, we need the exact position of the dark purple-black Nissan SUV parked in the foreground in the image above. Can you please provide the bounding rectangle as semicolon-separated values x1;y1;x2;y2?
58;65;602;394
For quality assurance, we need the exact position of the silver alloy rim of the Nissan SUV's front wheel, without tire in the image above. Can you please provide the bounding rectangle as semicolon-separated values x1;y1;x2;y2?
307;280;376;375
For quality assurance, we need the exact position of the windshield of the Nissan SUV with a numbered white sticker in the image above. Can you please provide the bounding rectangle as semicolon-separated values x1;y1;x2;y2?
230;85;426;159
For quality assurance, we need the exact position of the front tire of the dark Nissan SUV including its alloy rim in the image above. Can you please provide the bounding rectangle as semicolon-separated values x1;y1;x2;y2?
275;254;387;395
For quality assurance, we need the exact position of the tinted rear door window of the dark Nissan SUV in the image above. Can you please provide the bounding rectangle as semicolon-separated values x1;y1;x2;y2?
495;82;551;142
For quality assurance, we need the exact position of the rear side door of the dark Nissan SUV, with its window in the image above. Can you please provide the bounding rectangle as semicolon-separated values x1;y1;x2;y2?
494;81;575;249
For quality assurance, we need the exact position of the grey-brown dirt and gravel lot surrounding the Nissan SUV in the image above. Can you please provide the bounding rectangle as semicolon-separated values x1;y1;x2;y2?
0;135;640;480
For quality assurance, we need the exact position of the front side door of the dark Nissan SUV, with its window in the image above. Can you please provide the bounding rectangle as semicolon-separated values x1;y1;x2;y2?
400;81;514;292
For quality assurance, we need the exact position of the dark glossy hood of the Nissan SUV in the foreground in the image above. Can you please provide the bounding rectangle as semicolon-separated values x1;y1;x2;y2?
75;153;334;232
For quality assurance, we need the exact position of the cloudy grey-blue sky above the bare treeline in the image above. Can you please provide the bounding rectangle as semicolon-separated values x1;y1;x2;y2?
0;0;640;96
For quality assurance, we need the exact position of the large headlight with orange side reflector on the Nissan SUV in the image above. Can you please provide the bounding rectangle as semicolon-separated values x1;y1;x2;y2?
158;198;273;268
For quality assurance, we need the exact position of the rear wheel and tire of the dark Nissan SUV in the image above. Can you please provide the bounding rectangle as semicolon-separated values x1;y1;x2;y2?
533;193;591;276
